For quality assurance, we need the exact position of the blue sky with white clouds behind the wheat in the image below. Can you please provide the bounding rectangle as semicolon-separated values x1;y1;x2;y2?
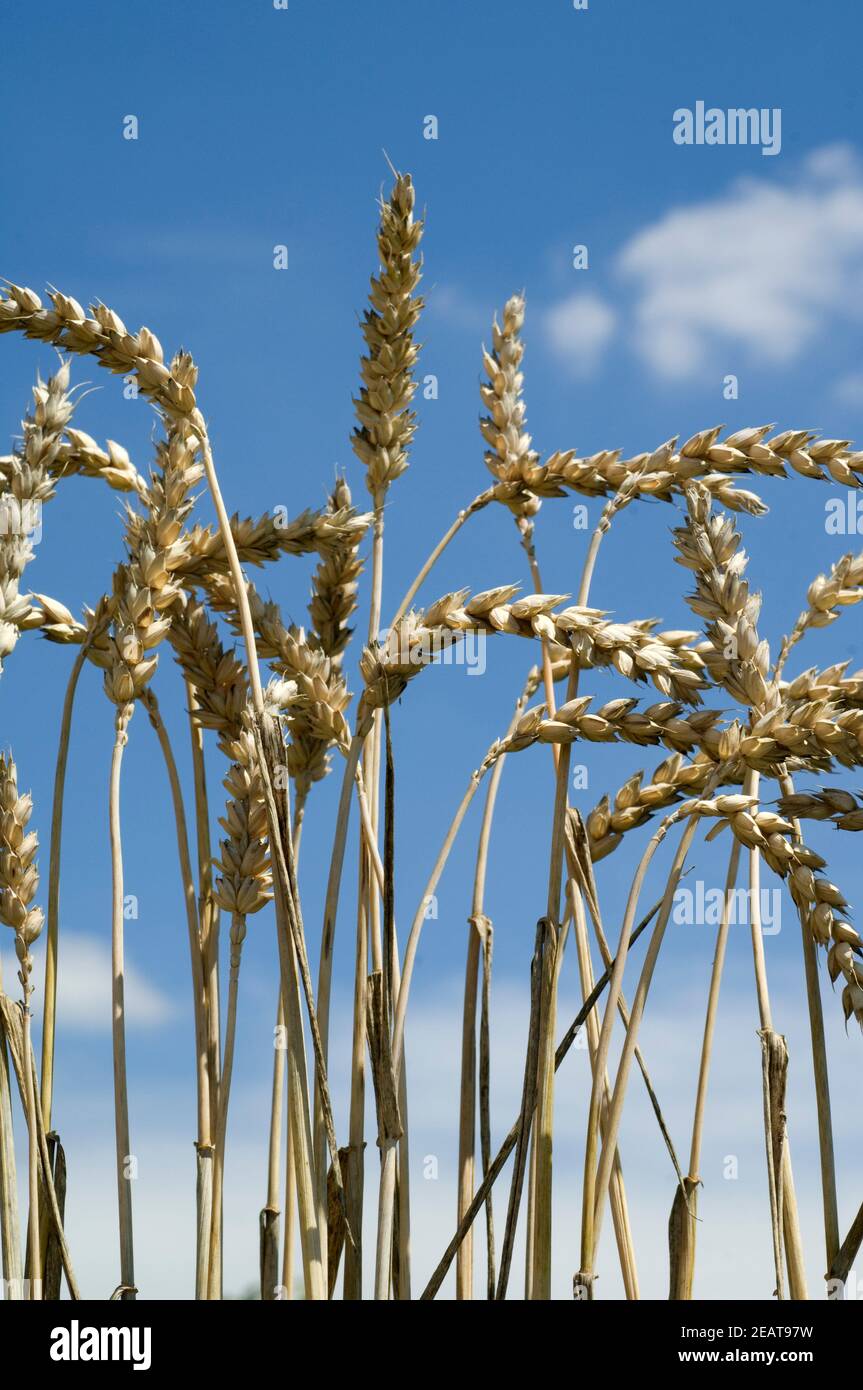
0;0;863;1297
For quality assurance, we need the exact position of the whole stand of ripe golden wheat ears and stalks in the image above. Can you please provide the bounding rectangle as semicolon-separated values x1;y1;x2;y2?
0;171;863;1301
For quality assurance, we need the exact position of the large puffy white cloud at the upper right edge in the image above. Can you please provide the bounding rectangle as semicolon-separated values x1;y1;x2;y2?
617;146;863;378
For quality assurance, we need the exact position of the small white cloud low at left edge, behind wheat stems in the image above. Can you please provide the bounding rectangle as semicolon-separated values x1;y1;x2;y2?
3;931;174;1033
